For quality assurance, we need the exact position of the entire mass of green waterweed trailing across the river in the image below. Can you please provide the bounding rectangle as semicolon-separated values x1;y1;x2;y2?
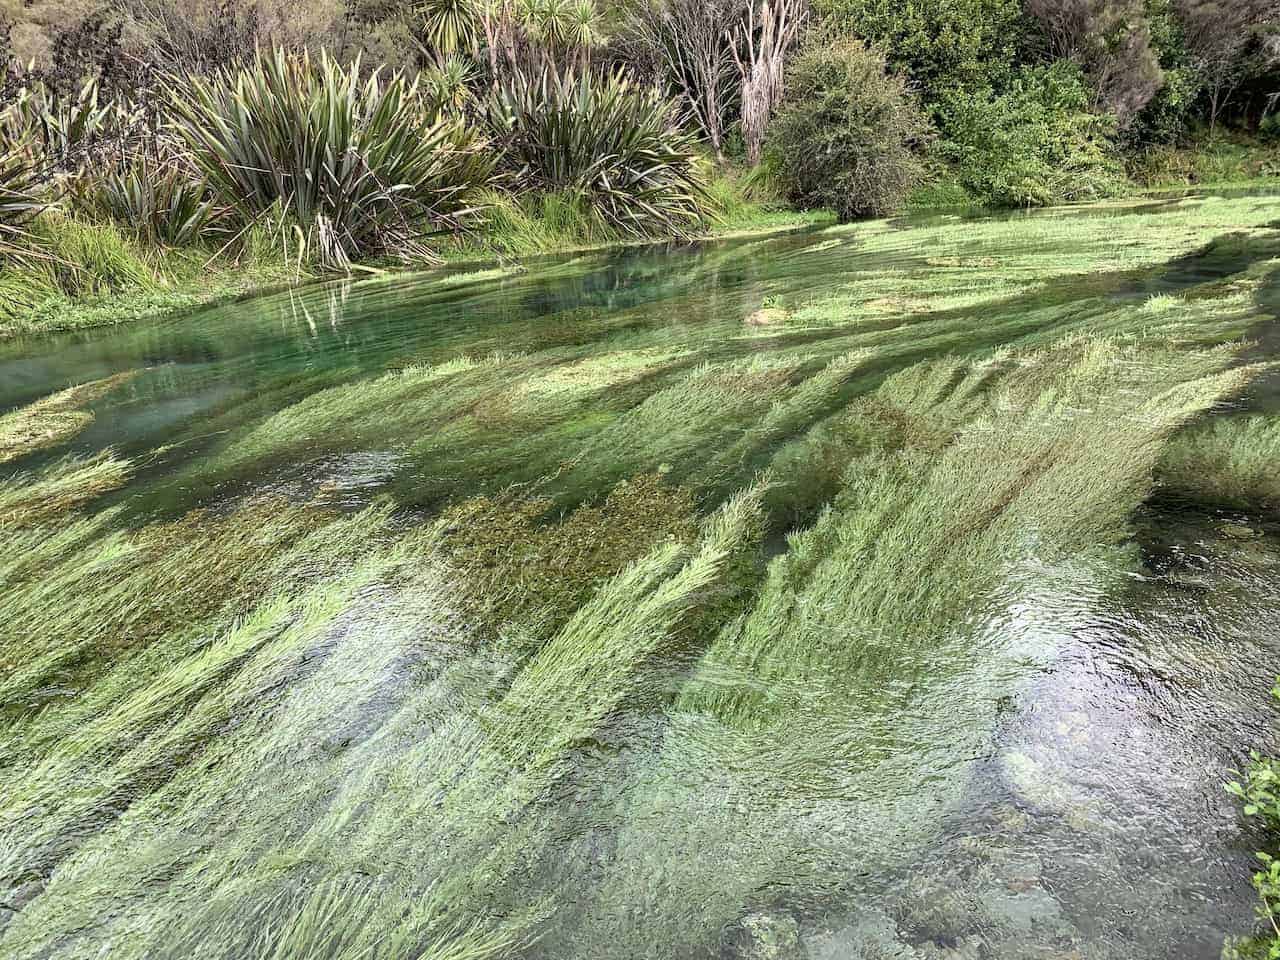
0;192;1274;960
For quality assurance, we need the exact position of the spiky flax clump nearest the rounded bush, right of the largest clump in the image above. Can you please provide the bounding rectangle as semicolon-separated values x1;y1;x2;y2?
485;70;708;239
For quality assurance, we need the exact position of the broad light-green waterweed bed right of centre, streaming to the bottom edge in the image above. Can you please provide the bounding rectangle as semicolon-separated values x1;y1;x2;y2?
550;340;1257;956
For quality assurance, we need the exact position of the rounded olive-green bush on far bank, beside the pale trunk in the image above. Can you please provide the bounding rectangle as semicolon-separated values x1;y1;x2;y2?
769;40;929;220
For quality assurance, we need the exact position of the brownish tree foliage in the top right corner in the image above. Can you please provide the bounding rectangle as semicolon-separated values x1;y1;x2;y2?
1175;0;1280;133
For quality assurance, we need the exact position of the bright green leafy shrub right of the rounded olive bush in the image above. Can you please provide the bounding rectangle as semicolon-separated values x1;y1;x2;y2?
938;60;1124;206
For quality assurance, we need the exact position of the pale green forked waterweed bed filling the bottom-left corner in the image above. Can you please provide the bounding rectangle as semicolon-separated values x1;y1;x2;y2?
0;494;758;957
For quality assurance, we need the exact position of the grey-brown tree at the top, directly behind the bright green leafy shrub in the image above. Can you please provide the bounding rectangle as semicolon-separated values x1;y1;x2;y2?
1027;0;1164;128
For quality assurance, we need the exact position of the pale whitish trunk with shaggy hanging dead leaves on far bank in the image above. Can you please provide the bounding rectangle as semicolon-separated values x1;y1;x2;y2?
733;0;809;166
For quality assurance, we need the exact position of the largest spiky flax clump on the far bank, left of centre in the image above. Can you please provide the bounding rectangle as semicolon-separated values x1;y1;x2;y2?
170;50;492;269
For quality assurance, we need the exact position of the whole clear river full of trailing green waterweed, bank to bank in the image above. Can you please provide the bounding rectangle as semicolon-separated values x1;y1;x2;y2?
0;196;1280;960
